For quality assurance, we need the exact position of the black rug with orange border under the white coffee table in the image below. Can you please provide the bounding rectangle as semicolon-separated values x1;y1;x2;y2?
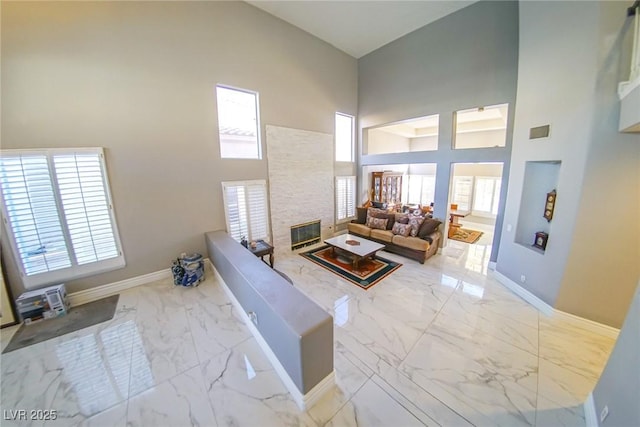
300;246;402;289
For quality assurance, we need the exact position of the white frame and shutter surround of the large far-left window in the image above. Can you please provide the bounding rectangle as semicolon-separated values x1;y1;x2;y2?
0;147;125;289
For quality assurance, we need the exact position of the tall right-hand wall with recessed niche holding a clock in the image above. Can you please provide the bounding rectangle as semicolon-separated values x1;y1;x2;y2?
496;2;640;327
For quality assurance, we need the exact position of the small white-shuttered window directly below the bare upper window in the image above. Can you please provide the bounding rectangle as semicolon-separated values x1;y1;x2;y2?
222;180;271;242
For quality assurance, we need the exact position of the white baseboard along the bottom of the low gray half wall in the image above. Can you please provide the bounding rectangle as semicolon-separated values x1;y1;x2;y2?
210;263;335;411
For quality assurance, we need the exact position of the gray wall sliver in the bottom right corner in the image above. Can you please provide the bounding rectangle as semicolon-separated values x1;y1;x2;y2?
593;283;640;427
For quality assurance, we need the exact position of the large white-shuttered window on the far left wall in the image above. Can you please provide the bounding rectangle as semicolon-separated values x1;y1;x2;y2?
0;148;125;288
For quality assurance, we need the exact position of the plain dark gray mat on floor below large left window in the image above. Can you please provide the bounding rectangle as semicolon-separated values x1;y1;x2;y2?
2;294;120;354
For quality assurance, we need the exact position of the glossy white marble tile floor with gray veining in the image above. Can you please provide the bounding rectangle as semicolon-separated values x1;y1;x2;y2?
0;241;614;427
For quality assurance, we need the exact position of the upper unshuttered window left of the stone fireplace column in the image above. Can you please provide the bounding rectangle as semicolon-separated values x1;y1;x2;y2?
216;85;262;159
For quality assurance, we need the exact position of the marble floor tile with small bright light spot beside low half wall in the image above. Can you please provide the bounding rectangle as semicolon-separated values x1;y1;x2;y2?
201;338;316;426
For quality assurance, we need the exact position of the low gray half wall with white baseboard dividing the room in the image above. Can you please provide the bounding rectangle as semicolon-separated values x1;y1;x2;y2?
205;231;335;410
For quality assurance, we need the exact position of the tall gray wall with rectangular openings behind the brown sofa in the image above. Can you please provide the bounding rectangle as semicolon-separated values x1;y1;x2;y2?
358;1;518;261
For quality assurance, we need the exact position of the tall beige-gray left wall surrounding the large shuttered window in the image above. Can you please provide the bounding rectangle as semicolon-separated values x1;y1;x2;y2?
1;2;357;295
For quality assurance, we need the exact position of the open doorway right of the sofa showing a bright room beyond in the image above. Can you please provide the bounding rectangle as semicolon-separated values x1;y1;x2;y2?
446;162;504;270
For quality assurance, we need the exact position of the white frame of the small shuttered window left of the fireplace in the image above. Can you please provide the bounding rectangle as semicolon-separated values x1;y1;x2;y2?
222;179;271;242
